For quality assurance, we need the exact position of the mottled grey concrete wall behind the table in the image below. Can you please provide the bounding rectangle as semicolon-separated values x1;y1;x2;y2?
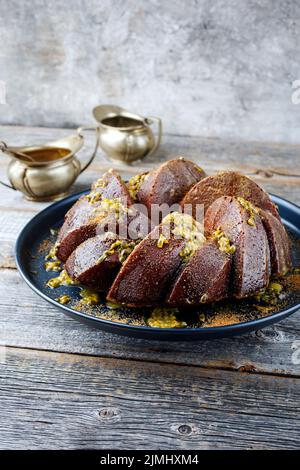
0;0;300;142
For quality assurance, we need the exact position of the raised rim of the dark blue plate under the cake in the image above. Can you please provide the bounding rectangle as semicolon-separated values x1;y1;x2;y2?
15;189;300;340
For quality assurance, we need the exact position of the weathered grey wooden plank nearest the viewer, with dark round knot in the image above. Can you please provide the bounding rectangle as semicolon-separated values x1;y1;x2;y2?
0;348;300;450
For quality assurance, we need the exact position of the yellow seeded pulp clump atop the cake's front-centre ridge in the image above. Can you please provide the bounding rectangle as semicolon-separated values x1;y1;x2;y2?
162;212;205;262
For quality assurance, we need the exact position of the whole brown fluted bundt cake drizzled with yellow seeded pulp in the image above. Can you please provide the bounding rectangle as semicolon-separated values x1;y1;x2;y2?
52;158;291;307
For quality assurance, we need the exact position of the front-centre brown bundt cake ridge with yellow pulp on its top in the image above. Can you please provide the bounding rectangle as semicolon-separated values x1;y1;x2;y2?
107;213;205;307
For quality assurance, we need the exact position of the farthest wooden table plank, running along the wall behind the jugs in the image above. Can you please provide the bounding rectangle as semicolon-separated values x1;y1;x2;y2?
0;126;300;176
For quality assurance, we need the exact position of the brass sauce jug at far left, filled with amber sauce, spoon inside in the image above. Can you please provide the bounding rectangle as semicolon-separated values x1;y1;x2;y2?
0;127;99;201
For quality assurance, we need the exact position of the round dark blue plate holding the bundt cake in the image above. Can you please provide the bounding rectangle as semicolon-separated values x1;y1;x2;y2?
16;192;300;341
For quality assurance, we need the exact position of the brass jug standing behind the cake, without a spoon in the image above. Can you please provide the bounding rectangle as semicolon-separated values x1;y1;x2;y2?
93;105;162;163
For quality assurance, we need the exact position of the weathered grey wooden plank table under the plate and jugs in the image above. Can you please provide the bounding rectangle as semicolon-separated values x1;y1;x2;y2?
0;127;300;449
